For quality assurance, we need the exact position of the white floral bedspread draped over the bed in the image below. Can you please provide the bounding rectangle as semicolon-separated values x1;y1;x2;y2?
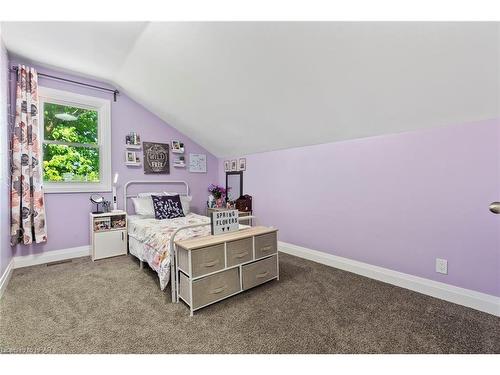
128;213;210;290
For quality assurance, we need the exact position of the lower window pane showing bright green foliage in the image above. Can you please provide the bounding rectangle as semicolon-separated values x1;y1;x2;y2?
43;144;99;182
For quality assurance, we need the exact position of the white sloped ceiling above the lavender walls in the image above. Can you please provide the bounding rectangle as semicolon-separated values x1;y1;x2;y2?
2;22;499;157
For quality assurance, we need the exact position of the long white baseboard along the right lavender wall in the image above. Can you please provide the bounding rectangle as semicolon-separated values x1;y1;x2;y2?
278;241;500;316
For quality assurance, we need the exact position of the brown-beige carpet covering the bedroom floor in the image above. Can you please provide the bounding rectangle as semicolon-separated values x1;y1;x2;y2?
0;254;500;353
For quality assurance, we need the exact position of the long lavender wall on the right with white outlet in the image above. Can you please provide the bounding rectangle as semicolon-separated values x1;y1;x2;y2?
224;120;500;296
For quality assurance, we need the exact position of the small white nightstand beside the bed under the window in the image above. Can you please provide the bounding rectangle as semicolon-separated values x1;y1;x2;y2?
90;211;127;260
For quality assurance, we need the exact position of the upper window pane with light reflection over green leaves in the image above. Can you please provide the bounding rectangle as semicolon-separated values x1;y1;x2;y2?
43;102;97;144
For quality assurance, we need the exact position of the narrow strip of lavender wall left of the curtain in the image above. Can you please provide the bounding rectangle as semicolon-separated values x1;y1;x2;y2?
0;30;12;278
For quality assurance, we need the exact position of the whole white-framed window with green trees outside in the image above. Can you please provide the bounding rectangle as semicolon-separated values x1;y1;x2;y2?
39;87;111;193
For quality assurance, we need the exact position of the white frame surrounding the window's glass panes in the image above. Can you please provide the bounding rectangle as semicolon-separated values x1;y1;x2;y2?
38;87;111;193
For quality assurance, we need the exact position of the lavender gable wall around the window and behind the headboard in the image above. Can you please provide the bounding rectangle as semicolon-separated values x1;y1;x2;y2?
10;59;217;255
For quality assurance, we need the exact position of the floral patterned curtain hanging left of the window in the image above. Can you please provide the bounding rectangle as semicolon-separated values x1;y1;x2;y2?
11;65;47;245
